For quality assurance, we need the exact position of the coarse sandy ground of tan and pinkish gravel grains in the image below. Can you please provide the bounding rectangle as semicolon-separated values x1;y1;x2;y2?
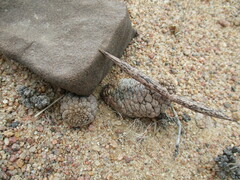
0;0;240;180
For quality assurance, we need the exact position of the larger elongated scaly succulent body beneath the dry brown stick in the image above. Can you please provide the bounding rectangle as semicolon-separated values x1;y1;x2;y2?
101;79;175;118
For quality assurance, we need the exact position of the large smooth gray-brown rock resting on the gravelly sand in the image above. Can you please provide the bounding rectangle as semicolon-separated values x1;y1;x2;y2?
0;0;135;95
